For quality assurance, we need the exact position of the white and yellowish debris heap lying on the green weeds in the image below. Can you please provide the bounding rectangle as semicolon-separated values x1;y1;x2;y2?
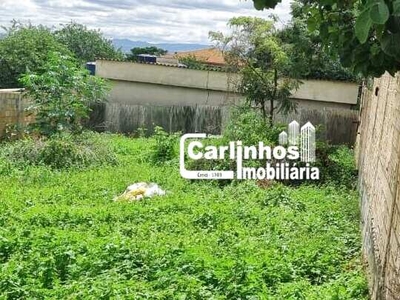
114;182;165;202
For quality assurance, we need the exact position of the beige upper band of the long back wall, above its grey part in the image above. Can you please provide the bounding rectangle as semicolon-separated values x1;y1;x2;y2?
96;60;358;105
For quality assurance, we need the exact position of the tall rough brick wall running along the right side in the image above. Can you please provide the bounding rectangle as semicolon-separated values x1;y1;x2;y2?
358;74;400;299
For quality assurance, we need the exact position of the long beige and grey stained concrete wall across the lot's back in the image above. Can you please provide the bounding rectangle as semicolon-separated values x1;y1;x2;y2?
96;60;358;144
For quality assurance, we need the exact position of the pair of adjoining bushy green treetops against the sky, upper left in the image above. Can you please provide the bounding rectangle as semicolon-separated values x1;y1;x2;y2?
0;21;123;89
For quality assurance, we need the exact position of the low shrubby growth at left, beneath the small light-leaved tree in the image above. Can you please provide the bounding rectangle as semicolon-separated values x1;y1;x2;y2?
0;133;117;169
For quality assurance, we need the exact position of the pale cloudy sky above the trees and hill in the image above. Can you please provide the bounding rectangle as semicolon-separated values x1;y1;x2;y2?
0;0;291;44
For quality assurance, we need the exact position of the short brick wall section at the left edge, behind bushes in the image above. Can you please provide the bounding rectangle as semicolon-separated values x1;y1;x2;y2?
0;90;32;136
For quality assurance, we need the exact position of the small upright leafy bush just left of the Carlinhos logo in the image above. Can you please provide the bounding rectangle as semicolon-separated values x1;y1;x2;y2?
151;126;180;164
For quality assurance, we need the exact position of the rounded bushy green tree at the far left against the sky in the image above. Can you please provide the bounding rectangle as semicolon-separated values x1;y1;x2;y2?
0;21;70;88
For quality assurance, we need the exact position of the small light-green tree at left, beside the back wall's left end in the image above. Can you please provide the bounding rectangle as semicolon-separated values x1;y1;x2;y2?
20;52;108;136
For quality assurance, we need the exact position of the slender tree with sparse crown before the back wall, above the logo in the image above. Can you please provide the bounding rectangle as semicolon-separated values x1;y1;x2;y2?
210;17;299;125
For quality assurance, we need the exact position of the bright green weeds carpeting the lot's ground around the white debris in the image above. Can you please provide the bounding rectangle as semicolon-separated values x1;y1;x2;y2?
0;135;367;300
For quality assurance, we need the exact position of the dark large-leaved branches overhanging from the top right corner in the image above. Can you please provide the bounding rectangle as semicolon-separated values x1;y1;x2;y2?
253;0;400;76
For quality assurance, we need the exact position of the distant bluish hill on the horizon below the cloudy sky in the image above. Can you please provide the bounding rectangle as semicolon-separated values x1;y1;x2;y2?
113;39;211;52
